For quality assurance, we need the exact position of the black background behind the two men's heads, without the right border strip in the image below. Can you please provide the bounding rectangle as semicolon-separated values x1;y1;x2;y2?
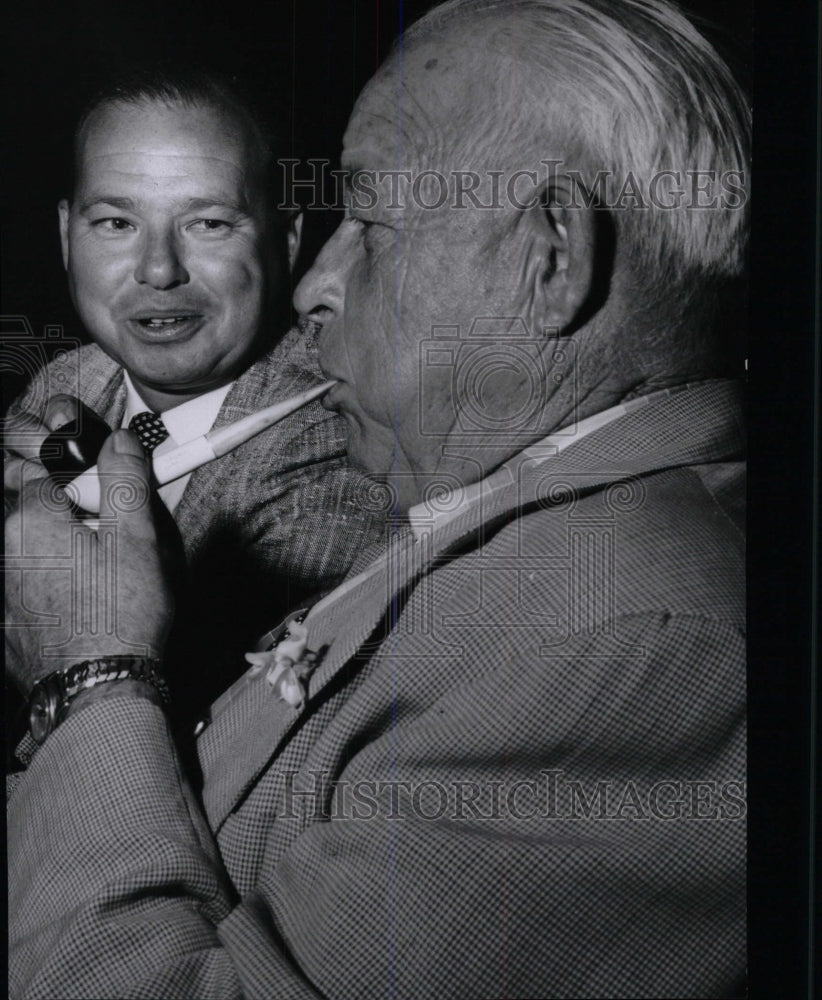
0;0;752;406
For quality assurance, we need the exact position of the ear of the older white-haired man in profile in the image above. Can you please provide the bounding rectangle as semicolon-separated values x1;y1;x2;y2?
534;180;604;334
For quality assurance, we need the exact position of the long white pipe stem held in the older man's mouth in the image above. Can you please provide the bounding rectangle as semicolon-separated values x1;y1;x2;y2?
60;382;334;514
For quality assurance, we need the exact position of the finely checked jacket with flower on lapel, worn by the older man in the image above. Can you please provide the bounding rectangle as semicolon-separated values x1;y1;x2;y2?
8;382;745;998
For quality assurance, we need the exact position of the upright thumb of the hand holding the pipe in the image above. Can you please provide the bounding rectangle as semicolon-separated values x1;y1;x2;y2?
97;430;155;539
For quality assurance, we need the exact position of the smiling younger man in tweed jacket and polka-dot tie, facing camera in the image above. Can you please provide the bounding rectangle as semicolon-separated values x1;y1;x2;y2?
4;73;380;744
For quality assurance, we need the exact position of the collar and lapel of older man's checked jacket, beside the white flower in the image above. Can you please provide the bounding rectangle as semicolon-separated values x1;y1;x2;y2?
199;382;744;828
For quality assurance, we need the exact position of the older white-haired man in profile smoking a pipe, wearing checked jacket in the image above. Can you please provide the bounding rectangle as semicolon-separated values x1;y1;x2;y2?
8;0;748;998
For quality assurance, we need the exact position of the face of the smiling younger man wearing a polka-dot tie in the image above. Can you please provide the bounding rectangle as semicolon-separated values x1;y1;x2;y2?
60;102;287;409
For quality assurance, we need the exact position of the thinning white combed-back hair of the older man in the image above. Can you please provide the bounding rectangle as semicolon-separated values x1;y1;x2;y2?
403;0;750;291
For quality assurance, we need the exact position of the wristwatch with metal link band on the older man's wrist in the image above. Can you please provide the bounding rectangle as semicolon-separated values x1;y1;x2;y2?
29;656;171;743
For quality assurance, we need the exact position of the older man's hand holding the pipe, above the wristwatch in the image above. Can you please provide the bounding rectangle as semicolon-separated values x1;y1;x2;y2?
6;431;172;693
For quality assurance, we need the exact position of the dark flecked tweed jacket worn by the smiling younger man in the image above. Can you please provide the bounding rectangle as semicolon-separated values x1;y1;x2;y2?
6;328;382;717
